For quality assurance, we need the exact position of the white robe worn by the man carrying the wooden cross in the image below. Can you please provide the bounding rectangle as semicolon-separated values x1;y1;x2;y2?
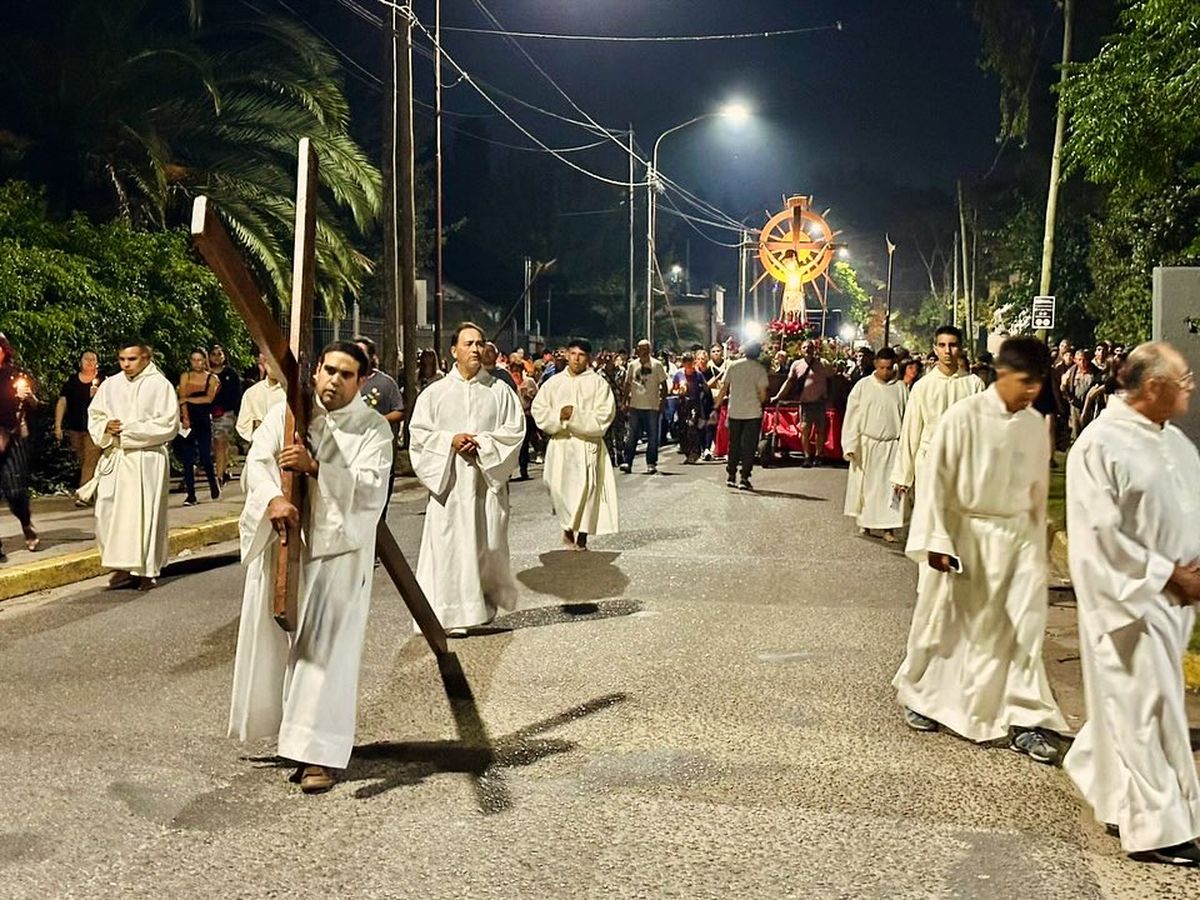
229;395;392;769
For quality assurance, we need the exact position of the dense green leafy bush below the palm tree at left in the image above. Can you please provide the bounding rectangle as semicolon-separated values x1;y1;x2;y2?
0;181;252;491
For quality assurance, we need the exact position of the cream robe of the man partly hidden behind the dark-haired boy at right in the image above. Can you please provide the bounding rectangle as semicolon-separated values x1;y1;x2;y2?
892;368;984;556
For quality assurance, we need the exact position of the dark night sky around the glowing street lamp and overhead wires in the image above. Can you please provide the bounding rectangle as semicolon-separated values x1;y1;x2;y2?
292;0;998;296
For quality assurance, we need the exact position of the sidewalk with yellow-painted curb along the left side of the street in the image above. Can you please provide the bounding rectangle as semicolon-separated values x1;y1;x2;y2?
0;478;419;602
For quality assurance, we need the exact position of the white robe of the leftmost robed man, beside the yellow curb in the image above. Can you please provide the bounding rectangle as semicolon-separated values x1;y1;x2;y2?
88;362;179;578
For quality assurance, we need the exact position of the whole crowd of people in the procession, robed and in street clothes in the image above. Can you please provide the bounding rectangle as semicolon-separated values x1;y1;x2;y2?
0;323;1200;866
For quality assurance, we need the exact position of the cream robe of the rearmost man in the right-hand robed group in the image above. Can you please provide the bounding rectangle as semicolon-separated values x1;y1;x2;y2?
841;376;908;529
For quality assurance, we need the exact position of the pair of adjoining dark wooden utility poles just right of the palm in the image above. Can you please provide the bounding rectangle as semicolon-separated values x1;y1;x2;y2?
380;7;424;408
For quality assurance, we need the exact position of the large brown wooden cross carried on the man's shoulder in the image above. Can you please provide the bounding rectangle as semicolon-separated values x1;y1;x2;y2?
192;138;448;659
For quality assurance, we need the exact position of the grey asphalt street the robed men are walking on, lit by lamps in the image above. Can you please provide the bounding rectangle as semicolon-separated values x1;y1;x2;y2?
0;455;1200;899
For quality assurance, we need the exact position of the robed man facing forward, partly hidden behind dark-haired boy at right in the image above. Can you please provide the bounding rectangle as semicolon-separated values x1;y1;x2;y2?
892;325;984;564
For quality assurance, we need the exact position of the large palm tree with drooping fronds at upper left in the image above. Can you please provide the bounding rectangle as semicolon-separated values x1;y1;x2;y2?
0;0;382;316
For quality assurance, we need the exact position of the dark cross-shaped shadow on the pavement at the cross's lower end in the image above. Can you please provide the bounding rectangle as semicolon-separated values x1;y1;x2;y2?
342;691;629;815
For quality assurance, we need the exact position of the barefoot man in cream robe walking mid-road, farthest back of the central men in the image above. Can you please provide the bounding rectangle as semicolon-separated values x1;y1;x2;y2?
530;338;617;550
